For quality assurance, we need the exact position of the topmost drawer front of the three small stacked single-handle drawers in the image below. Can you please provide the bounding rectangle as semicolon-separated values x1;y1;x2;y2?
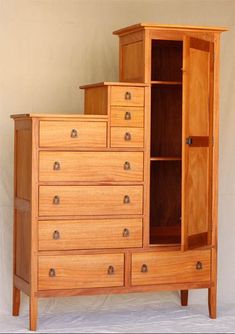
111;86;144;106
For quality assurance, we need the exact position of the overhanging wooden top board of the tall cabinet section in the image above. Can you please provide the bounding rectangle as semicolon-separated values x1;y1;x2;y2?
113;23;228;35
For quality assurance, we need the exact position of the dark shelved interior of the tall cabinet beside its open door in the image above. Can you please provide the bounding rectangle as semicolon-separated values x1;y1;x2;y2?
150;40;183;245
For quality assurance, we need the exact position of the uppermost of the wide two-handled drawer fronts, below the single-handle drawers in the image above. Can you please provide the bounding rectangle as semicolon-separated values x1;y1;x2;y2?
39;151;143;182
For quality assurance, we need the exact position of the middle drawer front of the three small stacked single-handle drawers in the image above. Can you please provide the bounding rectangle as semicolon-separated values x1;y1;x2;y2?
111;107;144;128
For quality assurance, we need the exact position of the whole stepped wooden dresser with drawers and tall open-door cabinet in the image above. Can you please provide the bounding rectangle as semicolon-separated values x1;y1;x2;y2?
12;24;228;330
